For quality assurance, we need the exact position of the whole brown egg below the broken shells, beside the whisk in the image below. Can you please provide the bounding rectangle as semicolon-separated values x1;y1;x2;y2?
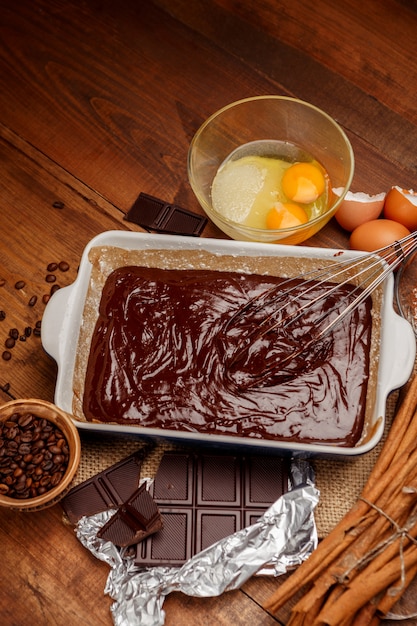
349;219;410;252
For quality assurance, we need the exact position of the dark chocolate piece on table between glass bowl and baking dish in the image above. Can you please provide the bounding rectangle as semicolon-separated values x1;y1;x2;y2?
125;193;207;237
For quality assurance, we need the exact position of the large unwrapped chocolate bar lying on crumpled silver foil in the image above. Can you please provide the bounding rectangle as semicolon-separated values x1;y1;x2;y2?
135;452;288;567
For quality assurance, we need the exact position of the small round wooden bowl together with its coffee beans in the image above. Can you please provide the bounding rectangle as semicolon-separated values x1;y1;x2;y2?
0;399;81;511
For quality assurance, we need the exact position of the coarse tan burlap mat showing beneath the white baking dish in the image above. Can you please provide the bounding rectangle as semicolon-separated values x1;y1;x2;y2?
71;392;398;538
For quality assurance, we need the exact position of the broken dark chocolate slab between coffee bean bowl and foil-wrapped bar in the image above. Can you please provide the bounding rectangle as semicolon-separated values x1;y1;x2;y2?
61;448;148;524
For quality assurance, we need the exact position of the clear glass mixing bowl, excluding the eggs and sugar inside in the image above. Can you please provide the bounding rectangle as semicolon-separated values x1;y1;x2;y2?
188;96;354;244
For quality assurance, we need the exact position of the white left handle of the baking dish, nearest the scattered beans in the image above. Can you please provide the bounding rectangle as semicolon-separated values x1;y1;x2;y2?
41;285;73;363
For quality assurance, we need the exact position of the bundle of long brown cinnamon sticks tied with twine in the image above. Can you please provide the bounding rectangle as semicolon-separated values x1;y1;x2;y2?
265;376;417;626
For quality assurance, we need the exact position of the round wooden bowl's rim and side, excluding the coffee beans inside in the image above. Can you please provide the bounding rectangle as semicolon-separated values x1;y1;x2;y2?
0;399;81;512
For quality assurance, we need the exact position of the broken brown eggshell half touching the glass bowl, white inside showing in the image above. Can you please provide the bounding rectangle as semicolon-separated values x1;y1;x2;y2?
333;189;386;232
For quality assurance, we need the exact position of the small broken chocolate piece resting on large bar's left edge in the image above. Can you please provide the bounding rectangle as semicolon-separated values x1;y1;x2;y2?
97;484;162;547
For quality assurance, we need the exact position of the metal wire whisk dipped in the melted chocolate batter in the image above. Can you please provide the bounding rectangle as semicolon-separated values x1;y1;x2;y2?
220;232;417;388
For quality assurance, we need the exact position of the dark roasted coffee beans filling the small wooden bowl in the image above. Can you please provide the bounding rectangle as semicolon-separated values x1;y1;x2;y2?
0;413;69;499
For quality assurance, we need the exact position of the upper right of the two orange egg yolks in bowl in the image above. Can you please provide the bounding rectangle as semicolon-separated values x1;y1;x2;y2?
282;163;326;204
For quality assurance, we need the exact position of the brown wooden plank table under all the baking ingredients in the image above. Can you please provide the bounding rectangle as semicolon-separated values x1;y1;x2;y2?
0;0;417;626
